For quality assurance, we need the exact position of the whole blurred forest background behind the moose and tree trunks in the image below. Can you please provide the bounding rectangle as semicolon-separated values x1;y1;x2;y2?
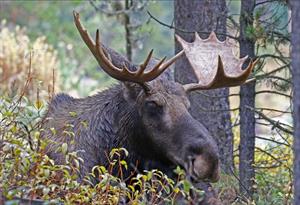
0;0;293;204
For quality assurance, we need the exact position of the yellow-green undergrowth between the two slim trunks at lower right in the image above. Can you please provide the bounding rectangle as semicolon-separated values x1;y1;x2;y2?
255;135;293;205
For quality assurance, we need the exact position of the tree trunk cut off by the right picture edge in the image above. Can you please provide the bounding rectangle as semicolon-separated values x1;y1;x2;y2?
291;0;300;205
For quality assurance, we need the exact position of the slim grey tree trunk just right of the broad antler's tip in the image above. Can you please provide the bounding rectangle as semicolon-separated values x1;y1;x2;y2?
239;0;255;198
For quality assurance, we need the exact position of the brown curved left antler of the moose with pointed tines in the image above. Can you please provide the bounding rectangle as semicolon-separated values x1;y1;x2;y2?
73;11;184;88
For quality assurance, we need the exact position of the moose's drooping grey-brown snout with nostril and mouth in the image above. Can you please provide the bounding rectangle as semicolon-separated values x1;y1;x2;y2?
179;116;220;182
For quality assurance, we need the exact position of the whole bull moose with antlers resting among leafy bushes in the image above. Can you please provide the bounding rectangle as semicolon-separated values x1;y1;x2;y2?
43;12;255;199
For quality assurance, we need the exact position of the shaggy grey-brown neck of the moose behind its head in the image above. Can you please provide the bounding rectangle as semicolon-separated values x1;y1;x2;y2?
89;85;141;163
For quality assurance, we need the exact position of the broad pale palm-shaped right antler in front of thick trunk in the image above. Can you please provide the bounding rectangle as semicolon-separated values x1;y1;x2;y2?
176;32;257;92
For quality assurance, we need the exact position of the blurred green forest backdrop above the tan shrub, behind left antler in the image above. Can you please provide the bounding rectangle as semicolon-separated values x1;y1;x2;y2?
0;1;174;96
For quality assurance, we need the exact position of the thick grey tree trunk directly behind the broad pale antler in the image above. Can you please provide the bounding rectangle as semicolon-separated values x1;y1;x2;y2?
174;0;233;173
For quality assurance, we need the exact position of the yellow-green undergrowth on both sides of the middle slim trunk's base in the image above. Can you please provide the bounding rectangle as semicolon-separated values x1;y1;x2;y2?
229;122;293;205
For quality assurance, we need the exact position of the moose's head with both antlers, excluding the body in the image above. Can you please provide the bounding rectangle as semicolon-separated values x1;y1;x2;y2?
60;12;255;181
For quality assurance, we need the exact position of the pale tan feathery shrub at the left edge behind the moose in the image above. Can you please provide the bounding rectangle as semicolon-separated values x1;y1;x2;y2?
0;21;59;99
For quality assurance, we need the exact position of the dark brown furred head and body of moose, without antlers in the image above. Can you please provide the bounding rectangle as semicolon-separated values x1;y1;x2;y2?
44;75;218;179
